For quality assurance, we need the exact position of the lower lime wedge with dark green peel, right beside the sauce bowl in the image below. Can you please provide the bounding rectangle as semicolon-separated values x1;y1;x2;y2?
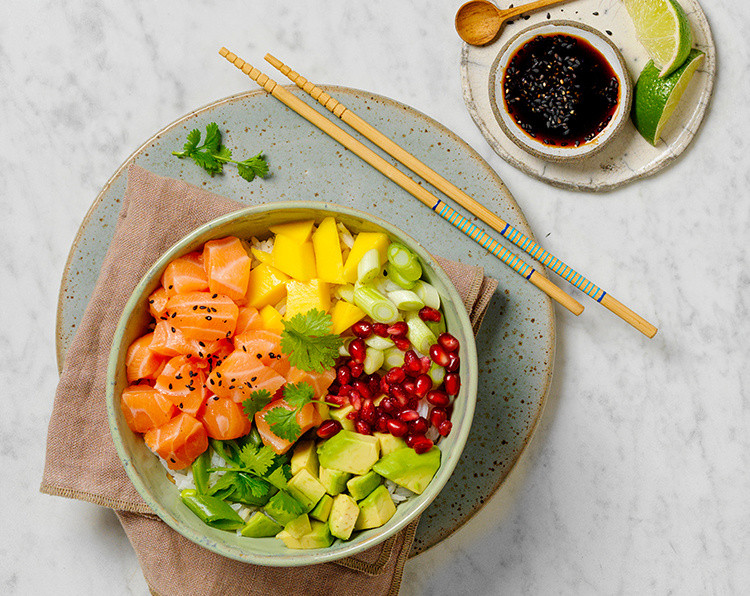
632;50;705;145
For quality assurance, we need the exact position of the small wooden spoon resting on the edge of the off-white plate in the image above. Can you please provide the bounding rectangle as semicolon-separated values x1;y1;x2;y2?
456;0;567;46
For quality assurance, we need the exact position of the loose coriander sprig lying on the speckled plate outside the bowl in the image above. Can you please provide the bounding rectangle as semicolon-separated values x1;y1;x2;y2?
172;122;268;182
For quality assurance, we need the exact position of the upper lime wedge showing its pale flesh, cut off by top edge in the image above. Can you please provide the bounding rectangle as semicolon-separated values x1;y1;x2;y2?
625;0;693;77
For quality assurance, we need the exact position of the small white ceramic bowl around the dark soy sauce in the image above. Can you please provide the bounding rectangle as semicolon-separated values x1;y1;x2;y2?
489;21;633;162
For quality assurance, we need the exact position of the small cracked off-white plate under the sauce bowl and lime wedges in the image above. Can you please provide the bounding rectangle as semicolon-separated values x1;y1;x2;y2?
461;0;716;191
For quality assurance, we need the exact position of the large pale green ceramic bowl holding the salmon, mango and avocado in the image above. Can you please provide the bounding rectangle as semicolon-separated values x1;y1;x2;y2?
106;202;478;567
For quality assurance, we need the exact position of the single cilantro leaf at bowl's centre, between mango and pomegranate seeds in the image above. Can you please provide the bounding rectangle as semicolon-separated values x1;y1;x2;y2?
281;309;343;372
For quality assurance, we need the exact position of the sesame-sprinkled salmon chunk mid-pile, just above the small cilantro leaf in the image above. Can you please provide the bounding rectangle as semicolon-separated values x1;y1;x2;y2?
207;350;286;402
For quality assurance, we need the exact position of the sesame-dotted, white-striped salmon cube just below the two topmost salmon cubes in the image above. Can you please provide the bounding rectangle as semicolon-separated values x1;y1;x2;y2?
167;292;239;341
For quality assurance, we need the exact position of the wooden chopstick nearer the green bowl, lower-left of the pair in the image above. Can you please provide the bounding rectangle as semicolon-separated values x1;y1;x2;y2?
219;48;583;315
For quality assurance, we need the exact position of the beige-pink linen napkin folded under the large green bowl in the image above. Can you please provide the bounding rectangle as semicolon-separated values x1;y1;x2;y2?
40;166;497;596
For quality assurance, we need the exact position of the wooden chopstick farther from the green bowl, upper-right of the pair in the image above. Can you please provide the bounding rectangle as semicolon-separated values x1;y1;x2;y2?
265;54;657;337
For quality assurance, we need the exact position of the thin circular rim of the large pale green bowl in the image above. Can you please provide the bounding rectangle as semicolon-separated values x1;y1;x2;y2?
105;201;478;567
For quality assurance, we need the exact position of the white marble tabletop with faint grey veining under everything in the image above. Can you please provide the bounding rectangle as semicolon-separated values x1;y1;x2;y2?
0;0;750;595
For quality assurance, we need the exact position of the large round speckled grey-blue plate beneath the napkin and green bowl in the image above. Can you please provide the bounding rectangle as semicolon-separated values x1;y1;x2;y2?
57;87;555;554
